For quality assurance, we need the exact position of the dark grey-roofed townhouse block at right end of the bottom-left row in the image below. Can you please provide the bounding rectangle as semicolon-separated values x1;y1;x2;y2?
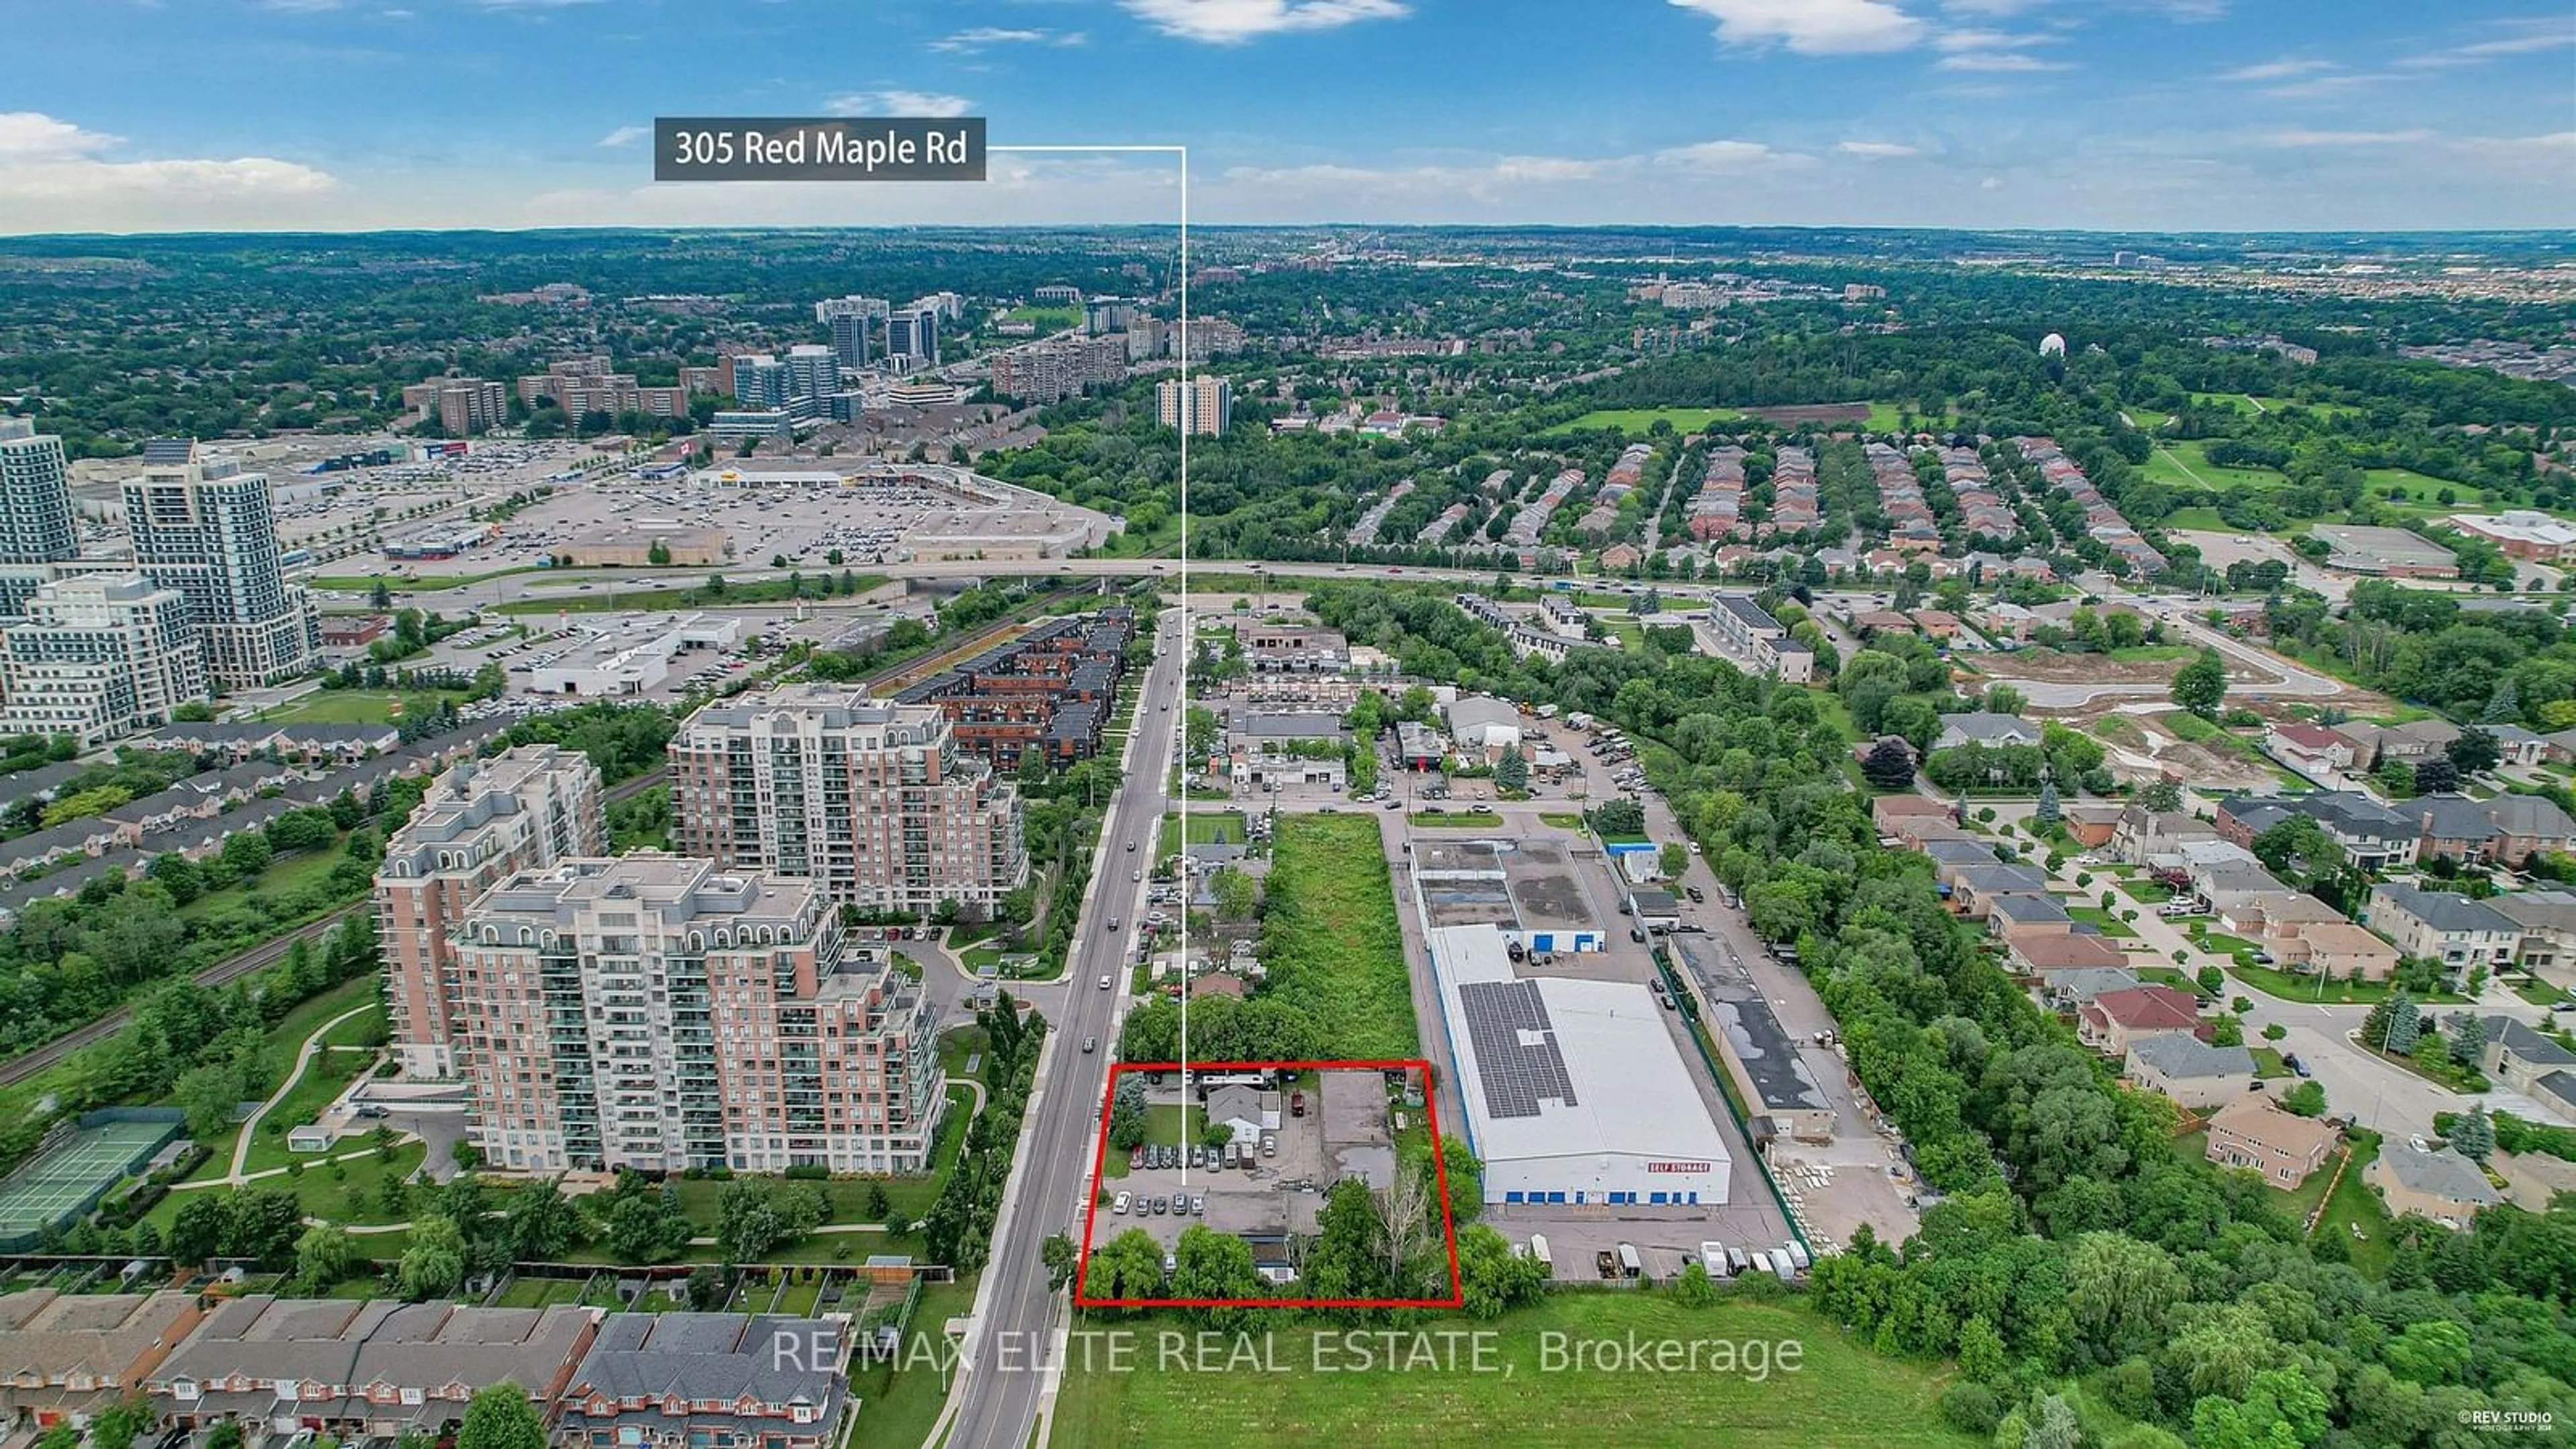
554;1312;855;1449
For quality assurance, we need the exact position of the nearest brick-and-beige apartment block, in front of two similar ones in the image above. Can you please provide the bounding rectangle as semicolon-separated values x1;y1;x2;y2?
456;851;945;1173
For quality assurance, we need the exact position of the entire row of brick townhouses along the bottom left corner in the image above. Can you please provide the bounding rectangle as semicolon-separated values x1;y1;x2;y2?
0;1289;855;1449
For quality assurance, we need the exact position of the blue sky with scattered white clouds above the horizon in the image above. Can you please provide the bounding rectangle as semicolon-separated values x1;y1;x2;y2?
0;0;2576;232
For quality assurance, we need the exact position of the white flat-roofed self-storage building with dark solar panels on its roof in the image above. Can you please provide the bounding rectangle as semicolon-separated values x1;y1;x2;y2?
1430;926;1731;1207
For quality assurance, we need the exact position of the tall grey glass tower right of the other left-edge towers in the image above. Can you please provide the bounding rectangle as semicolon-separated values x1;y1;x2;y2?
123;443;322;694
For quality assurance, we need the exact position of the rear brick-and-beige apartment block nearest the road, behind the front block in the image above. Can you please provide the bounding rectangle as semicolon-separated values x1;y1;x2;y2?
669;684;1028;913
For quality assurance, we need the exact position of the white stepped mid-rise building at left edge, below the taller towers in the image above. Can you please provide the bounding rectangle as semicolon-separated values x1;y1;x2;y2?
0;575;206;748
